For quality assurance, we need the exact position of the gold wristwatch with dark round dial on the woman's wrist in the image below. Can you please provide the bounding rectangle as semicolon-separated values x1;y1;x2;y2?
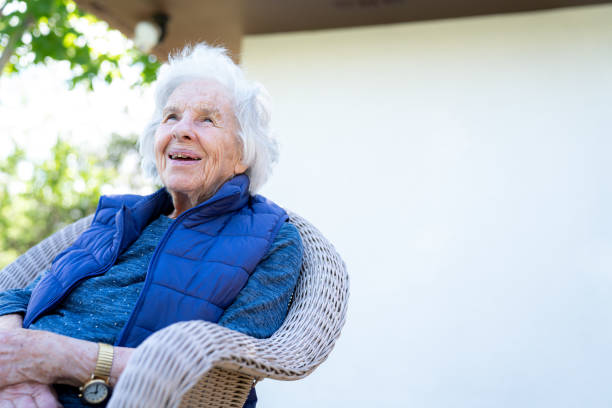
79;343;114;405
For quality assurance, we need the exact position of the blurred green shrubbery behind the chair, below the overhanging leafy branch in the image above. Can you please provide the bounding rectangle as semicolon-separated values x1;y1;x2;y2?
0;135;141;268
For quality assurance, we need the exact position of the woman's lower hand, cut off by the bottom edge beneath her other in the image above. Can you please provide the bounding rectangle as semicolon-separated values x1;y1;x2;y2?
0;382;62;408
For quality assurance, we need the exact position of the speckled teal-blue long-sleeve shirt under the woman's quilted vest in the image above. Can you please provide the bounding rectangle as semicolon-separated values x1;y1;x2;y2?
0;215;303;407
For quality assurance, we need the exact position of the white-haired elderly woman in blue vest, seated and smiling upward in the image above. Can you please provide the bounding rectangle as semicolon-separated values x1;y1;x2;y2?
0;44;302;407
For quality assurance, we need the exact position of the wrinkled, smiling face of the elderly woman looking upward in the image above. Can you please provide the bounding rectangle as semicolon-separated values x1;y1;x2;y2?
155;80;246;203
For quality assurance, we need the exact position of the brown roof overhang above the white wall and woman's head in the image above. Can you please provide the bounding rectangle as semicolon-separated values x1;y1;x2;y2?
76;0;612;59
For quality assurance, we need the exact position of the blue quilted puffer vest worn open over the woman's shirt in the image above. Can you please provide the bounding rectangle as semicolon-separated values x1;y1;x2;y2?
23;175;287;347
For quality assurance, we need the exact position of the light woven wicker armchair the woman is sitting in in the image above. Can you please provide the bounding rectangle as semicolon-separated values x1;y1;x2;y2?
0;213;349;408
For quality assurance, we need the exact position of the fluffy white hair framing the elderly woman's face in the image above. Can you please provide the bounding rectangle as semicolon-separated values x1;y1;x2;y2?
138;43;278;194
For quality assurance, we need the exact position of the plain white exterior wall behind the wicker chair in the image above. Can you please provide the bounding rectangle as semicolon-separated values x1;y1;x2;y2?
243;6;612;408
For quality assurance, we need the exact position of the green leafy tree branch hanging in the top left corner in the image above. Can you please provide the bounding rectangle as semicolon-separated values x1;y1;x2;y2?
0;0;160;89
